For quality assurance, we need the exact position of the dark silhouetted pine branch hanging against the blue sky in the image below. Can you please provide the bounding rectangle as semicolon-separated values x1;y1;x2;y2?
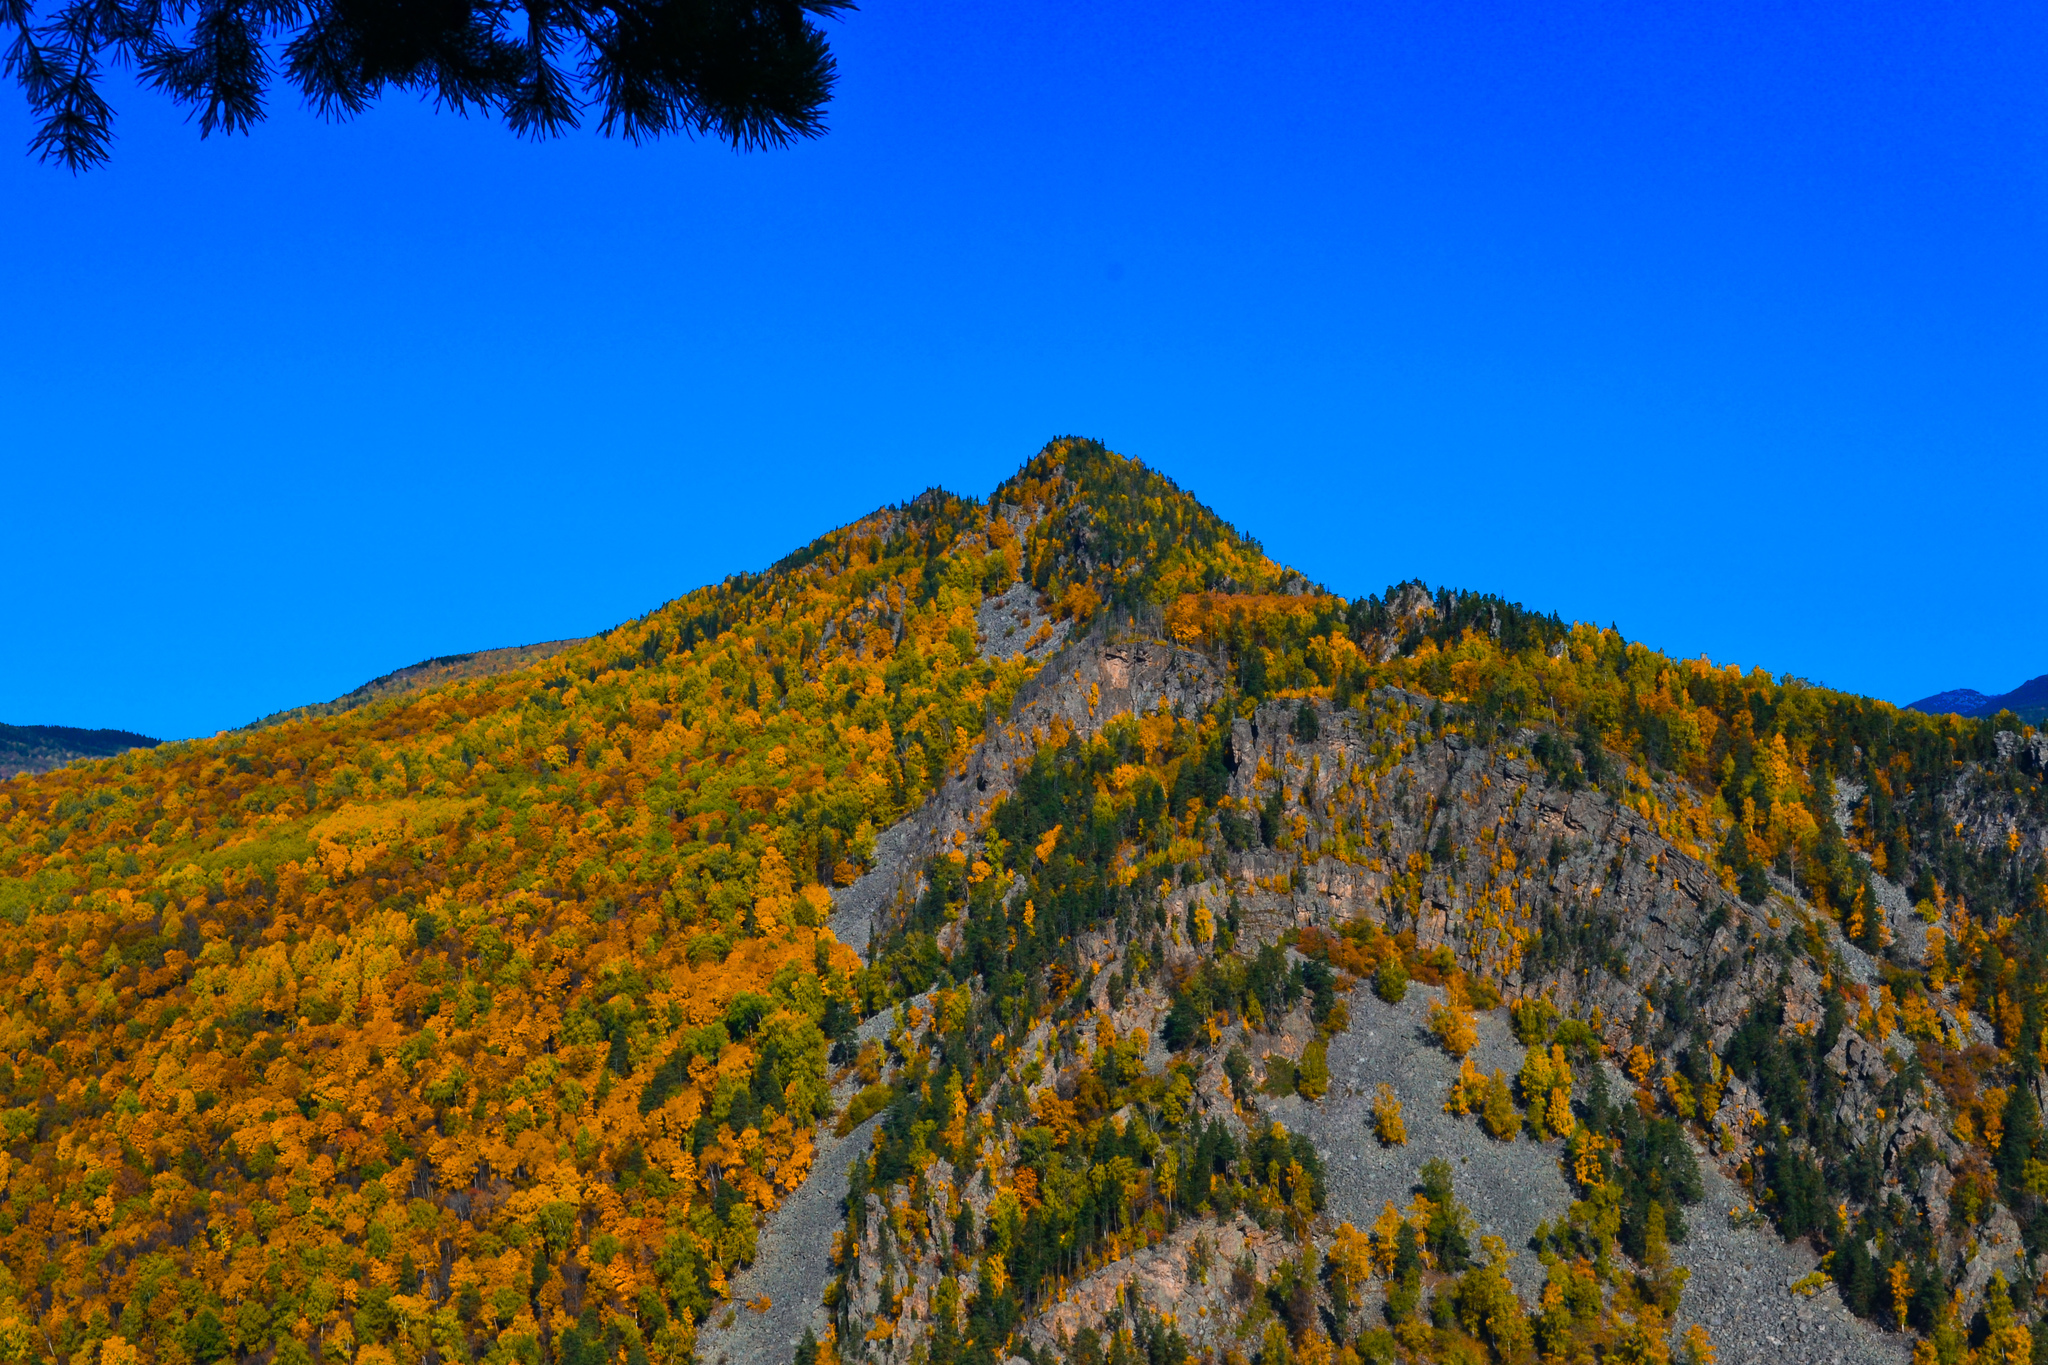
0;0;854;172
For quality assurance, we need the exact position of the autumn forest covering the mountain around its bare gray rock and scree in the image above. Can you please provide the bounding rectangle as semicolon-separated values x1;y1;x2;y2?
0;442;2048;1365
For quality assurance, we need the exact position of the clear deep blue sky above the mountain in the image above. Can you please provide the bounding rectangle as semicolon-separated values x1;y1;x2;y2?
0;0;2048;737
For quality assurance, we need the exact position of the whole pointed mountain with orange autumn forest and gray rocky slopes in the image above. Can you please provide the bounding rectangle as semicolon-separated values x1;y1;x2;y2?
0;440;2048;1365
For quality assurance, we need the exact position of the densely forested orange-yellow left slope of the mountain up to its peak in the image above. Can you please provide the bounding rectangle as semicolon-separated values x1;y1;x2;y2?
0;448;1276;1359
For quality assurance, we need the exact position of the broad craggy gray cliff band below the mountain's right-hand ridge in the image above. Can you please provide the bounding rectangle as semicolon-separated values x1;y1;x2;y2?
1231;694;1777;1042
